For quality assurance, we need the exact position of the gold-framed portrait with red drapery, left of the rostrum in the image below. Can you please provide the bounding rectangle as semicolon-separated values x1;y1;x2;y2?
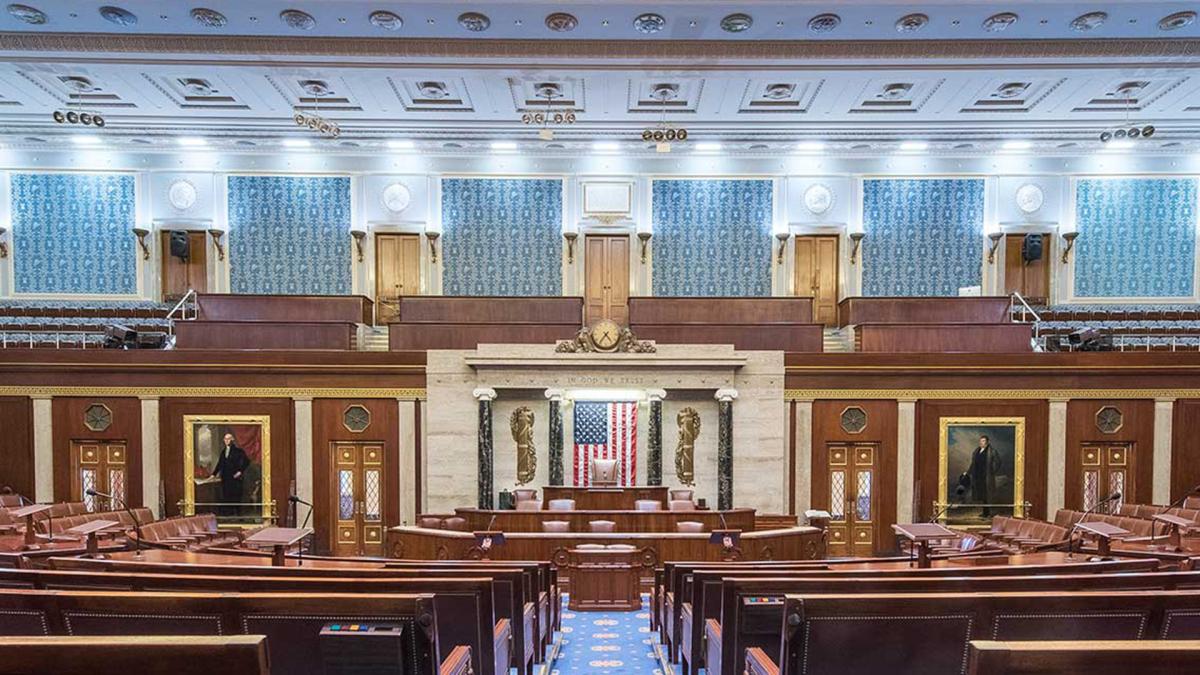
182;414;275;525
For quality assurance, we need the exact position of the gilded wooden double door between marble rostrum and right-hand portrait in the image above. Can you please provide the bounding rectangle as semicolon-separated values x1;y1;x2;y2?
826;443;881;556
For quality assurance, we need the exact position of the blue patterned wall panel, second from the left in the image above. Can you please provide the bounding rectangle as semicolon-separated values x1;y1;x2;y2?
229;175;352;295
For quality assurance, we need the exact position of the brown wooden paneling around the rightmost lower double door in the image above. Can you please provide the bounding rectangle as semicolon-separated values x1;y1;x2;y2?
1065;400;1154;506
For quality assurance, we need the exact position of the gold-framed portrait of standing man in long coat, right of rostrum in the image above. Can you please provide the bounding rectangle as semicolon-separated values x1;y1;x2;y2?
937;417;1025;526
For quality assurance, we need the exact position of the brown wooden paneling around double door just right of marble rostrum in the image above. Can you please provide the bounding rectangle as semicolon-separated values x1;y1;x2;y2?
811;401;896;552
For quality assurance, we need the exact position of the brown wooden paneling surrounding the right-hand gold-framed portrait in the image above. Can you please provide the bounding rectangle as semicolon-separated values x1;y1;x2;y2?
913;399;1052;521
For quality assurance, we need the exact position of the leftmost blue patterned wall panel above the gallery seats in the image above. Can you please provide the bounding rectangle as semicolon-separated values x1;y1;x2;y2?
10;173;139;295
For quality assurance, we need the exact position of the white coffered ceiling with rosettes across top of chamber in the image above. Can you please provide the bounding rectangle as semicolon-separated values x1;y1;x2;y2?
0;0;1200;154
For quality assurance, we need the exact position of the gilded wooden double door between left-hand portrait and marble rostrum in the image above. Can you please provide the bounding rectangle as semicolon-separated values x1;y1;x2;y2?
330;442;386;556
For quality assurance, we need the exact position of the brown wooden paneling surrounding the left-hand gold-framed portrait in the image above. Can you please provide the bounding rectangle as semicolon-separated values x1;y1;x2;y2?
158;398;295;519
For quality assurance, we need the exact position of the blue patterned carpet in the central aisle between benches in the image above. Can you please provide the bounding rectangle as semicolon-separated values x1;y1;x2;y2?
552;596;662;675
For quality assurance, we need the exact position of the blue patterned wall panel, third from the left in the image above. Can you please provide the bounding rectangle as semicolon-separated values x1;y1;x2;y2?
442;178;563;295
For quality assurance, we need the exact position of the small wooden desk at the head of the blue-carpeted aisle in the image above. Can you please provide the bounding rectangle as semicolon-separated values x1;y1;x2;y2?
566;546;642;611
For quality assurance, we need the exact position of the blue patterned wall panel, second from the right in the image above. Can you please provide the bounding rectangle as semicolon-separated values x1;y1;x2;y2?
862;179;984;297
